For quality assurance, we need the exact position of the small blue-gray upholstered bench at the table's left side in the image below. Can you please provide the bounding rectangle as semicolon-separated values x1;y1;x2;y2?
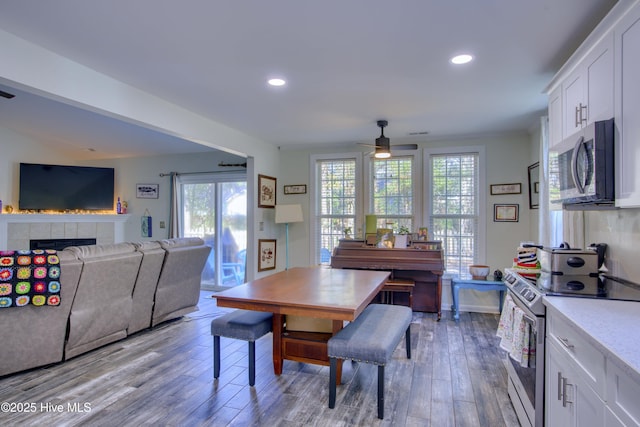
211;310;273;386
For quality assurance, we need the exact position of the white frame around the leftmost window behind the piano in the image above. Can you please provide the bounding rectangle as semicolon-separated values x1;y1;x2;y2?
309;152;366;264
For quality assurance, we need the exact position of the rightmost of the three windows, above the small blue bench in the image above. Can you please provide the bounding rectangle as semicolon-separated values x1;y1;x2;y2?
425;147;484;276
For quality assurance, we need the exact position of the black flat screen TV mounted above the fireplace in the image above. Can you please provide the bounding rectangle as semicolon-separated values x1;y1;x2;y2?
18;163;115;211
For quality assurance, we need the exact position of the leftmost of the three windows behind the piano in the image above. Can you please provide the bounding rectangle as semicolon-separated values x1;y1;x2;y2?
312;155;361;264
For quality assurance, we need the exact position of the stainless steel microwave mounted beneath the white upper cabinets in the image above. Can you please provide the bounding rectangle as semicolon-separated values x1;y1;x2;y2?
549;119;615;205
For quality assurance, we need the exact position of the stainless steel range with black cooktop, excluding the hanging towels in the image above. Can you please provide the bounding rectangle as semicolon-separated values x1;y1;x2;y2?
503;269;640;427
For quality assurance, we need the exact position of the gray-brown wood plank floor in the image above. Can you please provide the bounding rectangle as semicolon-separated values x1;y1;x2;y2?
0;292;519;427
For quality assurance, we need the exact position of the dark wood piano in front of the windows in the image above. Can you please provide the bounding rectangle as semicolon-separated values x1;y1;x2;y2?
331;239;444;320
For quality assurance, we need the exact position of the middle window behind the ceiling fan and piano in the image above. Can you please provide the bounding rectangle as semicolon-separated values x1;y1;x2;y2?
370;157;414;232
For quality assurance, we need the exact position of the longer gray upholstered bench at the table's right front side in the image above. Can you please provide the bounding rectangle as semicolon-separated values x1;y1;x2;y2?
327;304;412;419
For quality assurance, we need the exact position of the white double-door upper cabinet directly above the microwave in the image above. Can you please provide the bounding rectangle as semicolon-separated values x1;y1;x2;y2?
562;33;614;138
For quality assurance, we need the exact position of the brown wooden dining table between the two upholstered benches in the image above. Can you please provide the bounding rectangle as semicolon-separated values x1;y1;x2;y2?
215;267;390;378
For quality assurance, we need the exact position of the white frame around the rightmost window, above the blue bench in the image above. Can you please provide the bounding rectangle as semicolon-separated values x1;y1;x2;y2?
423;145;487;277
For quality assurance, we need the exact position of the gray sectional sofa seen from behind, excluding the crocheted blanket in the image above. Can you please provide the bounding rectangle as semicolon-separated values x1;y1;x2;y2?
0;238;211;376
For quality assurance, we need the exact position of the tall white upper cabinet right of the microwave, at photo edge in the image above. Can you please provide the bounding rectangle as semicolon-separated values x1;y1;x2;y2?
613;6;640;207
